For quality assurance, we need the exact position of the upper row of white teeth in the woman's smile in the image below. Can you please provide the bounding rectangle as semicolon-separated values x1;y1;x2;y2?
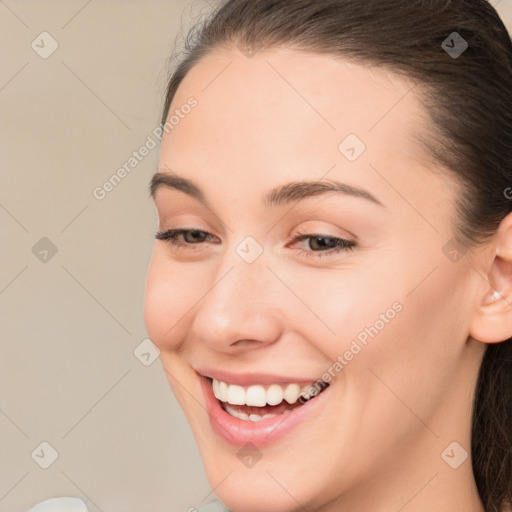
212;379;311;406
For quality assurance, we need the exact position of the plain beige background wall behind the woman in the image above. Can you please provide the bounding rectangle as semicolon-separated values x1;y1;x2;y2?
0;0;512;512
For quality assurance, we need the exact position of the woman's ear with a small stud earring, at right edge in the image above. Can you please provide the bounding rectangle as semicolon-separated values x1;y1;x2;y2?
469;209;512;343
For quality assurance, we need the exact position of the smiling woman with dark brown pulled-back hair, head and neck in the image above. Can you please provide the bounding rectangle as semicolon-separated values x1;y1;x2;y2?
27;0;512;512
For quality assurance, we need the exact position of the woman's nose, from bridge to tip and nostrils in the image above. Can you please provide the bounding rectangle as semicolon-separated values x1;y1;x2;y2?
192;250;286;353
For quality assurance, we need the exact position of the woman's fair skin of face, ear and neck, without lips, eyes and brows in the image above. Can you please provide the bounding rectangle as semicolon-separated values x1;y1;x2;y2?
144;49;512;512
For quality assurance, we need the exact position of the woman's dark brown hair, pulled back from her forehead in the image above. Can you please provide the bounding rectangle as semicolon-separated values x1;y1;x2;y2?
161;0;512;512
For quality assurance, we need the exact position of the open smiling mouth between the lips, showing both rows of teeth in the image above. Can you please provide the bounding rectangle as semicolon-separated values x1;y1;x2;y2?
206;377;329;422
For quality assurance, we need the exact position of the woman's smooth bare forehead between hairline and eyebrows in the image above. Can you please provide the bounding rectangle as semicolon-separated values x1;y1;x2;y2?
159;45;452;216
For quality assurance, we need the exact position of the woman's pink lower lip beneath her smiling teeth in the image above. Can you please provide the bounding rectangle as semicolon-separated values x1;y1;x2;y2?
198;374;330;447
